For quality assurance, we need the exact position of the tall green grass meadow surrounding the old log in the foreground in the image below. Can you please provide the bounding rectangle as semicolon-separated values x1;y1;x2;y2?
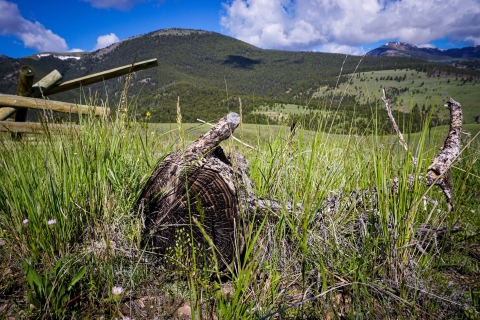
0;99;480;319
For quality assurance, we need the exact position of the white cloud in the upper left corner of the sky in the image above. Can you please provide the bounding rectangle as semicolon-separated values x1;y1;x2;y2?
0;0;68;52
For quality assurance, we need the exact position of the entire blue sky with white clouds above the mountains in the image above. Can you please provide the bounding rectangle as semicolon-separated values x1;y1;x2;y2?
0;0;480;58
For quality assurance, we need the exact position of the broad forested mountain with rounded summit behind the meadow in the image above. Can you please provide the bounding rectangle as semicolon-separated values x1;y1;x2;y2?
0;29;478;122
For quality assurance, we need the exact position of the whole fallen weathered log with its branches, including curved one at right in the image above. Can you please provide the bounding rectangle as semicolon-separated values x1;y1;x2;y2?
136;100;462;270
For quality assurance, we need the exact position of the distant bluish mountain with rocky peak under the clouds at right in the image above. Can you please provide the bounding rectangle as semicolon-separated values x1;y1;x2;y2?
367;42;480;62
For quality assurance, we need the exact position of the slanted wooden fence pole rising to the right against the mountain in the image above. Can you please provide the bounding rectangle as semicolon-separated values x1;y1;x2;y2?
43;59;158;96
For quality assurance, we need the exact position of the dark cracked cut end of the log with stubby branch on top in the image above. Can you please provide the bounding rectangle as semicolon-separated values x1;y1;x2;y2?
133;113;250;269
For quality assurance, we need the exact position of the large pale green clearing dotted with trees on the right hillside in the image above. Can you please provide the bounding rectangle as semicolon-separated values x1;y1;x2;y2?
314;69;480;123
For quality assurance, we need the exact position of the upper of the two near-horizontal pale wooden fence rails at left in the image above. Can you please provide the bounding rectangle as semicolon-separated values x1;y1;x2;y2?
0;94;110;116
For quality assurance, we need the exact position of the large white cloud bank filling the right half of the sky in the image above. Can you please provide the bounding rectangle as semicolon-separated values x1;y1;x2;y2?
220;0;480;53
